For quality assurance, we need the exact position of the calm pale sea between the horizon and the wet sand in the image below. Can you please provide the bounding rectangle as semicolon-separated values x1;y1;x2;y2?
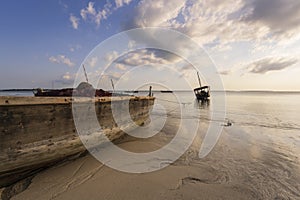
0;91;300;130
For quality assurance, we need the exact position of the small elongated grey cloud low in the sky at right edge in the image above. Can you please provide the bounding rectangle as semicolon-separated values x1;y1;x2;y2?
246;57;298;74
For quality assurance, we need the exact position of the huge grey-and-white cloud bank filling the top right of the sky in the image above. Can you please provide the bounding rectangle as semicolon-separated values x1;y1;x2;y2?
124;0;300;50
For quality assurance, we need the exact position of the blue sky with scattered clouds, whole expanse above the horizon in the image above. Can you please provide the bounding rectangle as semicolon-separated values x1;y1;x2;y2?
0;0;300;91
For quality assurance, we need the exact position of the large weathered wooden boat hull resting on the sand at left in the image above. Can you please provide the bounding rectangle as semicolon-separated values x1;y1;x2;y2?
0;85;155;187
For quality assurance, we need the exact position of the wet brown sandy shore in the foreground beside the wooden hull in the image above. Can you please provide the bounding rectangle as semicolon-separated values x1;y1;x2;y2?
8;119;300;200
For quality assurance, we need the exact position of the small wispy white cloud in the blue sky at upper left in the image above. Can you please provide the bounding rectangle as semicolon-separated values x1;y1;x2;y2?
80;2;111;26
